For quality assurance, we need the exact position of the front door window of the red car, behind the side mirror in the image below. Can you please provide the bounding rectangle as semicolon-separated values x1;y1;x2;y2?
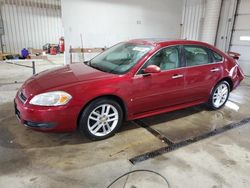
138;46;181;74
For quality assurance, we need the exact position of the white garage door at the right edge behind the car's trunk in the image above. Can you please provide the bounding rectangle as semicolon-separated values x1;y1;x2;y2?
231;0;250;76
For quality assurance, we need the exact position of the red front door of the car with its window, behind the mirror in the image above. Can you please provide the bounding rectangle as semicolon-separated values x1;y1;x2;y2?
132;46;185;114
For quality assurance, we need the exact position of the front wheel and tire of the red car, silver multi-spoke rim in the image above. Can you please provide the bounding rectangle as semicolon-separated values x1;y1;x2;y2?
78;98;123;140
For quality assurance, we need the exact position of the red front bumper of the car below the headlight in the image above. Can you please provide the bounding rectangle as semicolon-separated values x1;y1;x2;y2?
14;94;80;132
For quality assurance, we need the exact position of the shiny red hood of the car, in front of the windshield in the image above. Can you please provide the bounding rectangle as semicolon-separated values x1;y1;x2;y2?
22;63;116;96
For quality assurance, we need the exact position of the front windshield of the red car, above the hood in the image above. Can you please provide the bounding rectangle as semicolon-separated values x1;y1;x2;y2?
88;43;152;74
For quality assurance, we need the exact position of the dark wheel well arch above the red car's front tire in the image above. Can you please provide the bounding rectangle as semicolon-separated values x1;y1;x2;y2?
77;95;127;128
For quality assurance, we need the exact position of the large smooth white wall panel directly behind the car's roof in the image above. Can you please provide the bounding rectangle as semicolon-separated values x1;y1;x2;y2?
62;0;183;61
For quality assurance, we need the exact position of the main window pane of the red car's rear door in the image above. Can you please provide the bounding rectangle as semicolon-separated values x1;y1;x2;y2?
184;46;211;66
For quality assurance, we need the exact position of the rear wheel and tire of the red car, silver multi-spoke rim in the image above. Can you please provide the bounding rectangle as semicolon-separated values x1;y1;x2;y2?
208;81;230;110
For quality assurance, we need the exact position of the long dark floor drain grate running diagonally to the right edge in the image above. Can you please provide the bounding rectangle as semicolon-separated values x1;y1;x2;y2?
129;117;250;165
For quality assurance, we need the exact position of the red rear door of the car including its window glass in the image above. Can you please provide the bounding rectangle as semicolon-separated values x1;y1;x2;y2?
183;45;223;102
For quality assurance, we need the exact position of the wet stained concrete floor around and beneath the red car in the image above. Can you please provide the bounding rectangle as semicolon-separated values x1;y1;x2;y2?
0;58;250;188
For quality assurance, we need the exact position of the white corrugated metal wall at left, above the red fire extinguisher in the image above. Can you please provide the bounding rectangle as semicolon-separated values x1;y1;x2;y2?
0;0;63;53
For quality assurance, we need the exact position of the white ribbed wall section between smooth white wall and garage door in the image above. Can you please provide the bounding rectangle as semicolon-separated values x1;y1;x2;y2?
182;0;222;45
